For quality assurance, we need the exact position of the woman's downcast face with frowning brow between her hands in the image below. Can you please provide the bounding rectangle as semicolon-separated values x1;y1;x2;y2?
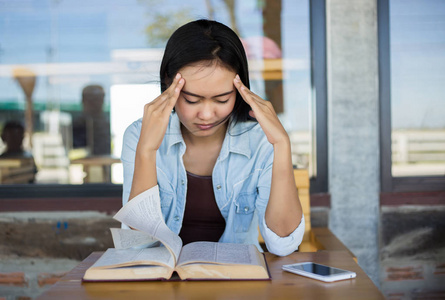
175;63;236;137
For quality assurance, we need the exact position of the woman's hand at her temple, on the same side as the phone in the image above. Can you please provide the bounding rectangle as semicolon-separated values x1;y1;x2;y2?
233;75;289;145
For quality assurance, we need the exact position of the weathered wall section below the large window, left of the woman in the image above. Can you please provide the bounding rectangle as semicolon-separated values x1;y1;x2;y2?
0;211;120;300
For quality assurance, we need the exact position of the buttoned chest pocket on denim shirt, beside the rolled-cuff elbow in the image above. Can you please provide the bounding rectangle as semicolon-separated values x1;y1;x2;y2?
234;192;257;233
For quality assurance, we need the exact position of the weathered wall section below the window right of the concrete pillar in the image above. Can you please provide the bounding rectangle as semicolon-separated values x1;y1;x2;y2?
380;206;445;300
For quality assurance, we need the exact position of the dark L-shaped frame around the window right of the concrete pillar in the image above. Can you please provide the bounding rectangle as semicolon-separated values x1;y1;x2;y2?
377;0;445;192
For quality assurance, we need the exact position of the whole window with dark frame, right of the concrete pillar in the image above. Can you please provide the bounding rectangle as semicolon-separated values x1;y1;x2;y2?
379;0;445;191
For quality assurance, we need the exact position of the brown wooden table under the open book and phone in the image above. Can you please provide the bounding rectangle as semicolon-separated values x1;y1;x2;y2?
37;251;384;300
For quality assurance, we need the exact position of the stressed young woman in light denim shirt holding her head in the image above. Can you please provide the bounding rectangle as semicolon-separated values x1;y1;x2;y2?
122;20;304;255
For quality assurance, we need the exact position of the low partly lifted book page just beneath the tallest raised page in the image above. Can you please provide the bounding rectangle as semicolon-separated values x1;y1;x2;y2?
110;228;159;249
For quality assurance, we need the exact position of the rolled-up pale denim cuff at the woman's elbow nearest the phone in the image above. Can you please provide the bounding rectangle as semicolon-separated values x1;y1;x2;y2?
261;215;305;256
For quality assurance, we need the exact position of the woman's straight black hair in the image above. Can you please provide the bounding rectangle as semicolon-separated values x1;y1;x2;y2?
160;19;251;122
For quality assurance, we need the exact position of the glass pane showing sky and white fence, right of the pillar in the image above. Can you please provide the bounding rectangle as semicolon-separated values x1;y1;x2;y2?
389;0;445;177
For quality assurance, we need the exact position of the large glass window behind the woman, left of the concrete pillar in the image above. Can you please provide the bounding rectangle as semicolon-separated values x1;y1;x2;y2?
0;0;316;190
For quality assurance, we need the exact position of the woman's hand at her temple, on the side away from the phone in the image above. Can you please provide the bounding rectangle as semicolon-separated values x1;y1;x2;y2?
137;73;185;154
